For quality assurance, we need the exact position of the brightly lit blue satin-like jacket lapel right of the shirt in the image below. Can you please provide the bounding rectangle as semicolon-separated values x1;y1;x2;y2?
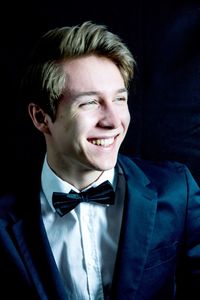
113;158;157;299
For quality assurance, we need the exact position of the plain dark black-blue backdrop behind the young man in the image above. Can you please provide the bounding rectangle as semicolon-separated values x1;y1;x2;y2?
0;0;200;190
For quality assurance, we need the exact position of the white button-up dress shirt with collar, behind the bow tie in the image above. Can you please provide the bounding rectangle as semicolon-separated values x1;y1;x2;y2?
40;157;123;300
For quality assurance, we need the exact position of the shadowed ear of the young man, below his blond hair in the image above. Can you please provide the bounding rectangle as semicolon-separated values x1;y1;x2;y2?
28;103;50;133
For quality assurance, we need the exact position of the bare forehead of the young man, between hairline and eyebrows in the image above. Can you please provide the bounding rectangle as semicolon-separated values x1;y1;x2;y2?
64;55;125;92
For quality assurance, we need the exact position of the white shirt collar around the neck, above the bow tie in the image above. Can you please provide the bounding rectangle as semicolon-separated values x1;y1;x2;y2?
41;156;116;210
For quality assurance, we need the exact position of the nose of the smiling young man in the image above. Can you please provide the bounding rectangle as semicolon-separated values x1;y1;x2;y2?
98;102;120;129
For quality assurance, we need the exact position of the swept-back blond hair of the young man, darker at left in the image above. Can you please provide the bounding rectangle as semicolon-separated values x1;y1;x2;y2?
22;21;135;118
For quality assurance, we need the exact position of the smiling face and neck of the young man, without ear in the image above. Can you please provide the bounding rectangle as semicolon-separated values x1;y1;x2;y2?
41;55;130;185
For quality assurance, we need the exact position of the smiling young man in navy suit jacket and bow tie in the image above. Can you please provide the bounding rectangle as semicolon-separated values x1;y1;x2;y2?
0;22;200;300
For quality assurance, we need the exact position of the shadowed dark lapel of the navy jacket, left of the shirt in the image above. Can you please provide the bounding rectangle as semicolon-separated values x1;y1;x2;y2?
9;160;68;300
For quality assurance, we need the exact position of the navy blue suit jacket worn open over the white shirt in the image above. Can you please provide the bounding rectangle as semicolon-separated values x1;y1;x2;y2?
0;155;200;300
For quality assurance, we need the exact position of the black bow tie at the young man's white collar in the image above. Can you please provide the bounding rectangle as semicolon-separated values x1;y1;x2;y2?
52;180;115;217
